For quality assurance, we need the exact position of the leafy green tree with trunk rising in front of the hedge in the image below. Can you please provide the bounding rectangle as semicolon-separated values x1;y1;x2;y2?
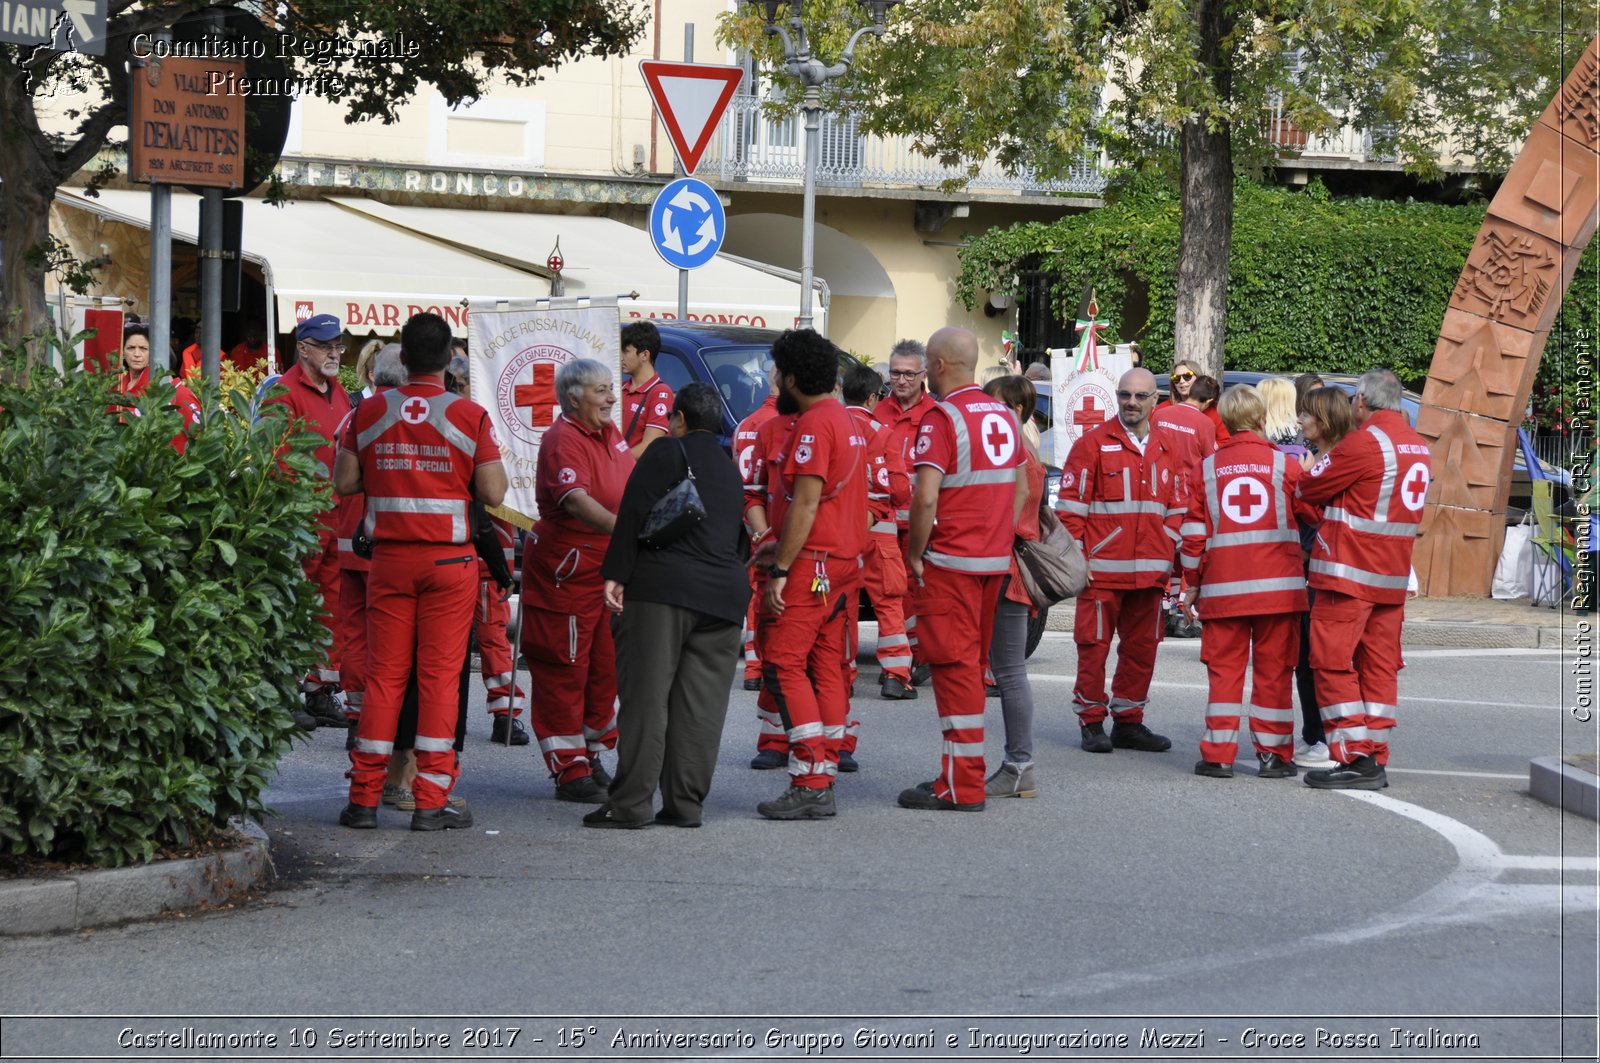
726;0;1574;379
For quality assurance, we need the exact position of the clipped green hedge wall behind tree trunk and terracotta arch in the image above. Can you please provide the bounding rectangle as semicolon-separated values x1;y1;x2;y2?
958;178;1600;423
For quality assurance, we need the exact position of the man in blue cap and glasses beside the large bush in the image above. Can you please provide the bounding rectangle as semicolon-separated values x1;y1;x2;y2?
267;314;352;727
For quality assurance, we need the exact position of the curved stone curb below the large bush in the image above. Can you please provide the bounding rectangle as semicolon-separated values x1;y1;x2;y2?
0;820;274;935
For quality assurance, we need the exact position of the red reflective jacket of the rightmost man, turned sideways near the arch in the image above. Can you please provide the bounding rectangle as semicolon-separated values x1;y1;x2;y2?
1299;410;1432;605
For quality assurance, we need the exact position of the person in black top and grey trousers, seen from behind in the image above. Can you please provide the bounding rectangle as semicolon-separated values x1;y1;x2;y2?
584;383;750;829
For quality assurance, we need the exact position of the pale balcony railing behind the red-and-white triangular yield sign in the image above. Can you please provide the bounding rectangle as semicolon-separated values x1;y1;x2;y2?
701;94;1106;195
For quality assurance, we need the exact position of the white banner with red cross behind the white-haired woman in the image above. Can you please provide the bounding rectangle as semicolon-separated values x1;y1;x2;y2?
467;298;622;528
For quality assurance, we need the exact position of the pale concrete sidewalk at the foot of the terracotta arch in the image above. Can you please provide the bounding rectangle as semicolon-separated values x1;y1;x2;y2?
1046;597;1589;650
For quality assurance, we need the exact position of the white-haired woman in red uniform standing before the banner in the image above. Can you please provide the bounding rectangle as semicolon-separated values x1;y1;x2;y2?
522;359;634;805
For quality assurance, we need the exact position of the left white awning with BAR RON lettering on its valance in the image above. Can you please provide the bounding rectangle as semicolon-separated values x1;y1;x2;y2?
56;189;544;336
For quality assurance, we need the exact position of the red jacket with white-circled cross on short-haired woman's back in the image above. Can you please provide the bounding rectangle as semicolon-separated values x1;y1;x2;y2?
1181;432;1317;618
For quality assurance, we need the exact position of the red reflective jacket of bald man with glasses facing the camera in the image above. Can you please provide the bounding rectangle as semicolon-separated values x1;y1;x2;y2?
1056;418;1189;591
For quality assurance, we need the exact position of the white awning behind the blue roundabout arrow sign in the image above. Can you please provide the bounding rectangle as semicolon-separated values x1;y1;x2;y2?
326;195;826;331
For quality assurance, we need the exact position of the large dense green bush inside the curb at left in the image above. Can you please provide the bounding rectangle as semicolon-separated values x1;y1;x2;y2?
0;344;328;864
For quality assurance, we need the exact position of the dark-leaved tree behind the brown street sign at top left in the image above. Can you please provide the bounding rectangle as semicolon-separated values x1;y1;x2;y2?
0;0;646;357
